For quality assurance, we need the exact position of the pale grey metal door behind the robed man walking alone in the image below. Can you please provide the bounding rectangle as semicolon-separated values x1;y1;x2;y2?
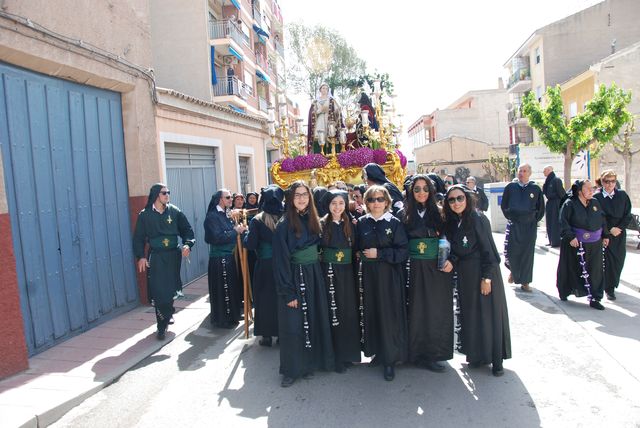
165;143;217;284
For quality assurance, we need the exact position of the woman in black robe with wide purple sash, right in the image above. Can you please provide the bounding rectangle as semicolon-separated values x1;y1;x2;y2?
556;180;609;310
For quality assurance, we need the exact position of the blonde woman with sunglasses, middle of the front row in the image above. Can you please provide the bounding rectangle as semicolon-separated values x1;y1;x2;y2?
356;185;408;381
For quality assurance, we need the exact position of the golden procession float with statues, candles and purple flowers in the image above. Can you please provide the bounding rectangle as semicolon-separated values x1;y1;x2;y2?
268;80;407;188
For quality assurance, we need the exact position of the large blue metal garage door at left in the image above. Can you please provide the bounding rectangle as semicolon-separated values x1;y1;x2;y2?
0;63;138;355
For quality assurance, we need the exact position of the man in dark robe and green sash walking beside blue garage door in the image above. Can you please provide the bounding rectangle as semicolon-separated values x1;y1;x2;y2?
133;183;196;340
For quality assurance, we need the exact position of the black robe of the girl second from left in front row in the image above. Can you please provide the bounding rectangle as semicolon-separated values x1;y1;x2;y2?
321;221;360;365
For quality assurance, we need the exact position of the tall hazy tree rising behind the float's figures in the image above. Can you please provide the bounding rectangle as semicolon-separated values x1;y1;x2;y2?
287;23;366;105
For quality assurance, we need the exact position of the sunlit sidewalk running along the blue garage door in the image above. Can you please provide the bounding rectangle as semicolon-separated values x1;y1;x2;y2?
0;276;210;428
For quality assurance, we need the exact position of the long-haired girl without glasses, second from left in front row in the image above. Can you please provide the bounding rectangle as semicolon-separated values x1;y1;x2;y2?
320;190;360;373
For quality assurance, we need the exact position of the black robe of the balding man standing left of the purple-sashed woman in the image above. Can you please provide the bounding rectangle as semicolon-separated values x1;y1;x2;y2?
500;181;544;284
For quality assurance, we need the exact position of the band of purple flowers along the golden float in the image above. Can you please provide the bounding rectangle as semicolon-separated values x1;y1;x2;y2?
279;147;407;172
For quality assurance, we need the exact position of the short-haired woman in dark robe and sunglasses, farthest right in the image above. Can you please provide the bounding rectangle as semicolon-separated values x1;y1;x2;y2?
594;170;632;300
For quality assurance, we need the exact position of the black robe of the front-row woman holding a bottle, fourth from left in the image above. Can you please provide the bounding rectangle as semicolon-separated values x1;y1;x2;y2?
399;210;453;362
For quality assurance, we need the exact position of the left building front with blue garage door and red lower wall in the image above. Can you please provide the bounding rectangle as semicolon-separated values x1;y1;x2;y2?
0;0;161;378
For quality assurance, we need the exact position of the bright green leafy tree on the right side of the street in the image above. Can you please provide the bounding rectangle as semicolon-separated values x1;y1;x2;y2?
522;84;631;187
